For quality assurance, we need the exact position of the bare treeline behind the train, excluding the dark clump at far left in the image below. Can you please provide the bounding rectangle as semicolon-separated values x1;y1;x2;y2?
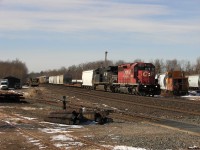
33;57;200;79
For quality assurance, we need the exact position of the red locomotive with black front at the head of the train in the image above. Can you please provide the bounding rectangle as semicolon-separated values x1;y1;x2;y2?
111;62;160;96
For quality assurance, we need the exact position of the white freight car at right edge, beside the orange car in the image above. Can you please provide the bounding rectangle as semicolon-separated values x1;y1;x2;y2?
188;75;200;90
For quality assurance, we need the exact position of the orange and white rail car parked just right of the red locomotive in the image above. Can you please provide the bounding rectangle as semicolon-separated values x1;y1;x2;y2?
158;71;189;95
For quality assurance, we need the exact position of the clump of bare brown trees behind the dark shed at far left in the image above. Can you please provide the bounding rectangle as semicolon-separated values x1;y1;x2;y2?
0;59;28;83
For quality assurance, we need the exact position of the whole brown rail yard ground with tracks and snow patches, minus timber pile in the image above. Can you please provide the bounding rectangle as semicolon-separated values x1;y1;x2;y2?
0;84;200;149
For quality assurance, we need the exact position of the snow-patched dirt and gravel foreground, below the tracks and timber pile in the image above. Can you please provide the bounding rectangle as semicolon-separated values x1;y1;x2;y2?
0;89;200;150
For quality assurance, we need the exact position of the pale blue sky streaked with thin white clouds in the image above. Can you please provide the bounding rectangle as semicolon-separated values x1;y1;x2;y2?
0;0;200;72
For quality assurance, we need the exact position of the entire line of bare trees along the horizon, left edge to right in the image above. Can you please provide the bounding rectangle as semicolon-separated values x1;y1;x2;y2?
0;57;200;83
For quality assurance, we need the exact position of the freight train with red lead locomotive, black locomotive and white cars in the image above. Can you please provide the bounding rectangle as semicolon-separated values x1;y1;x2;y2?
49;62;160;96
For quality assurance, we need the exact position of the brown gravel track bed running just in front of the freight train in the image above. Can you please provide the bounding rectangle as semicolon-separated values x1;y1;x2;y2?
41;86;200;115
